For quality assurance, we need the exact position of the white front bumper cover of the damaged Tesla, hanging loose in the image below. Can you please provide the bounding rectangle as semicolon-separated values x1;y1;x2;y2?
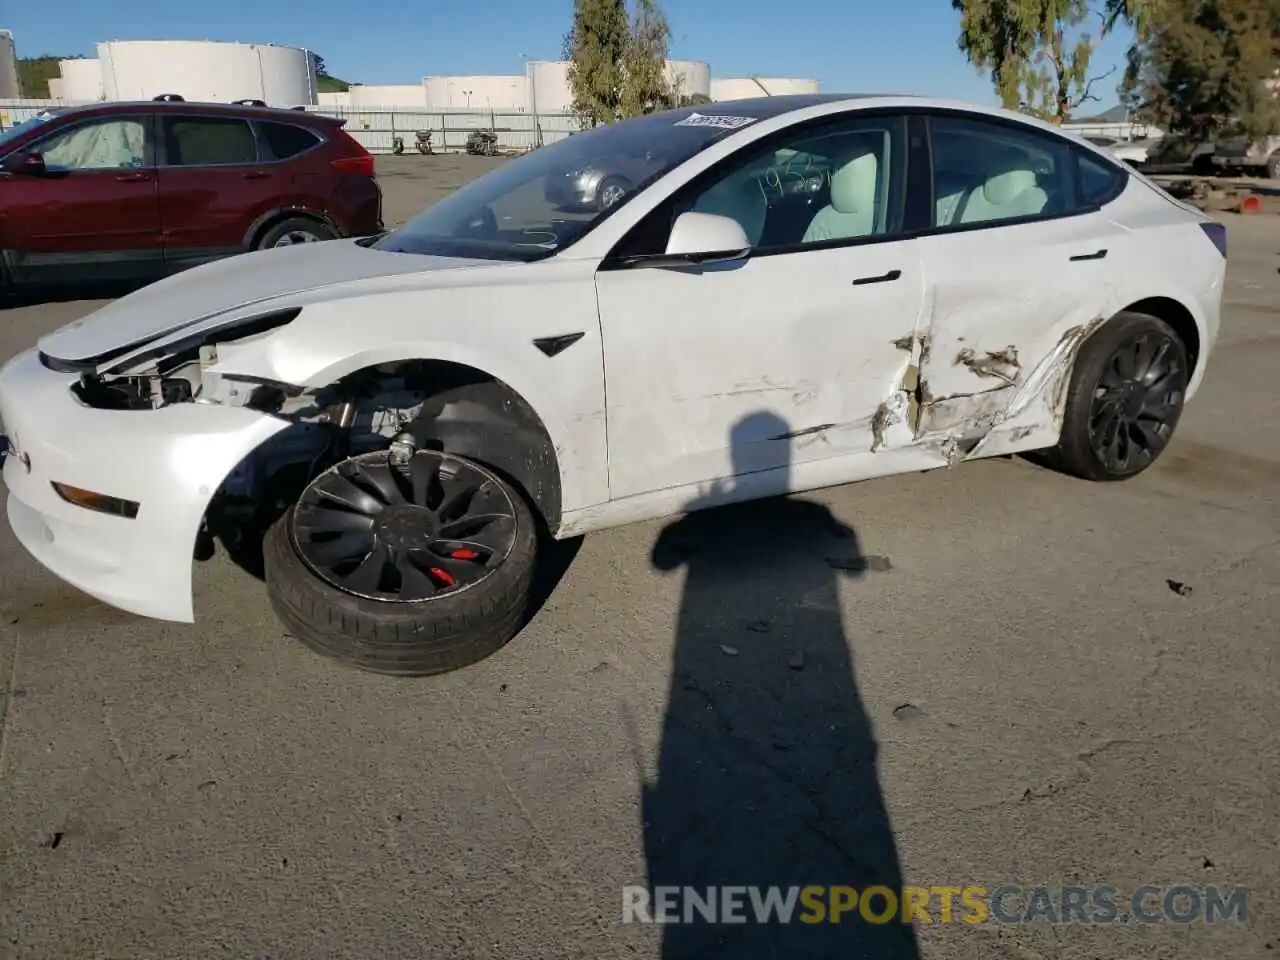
0;349;288;622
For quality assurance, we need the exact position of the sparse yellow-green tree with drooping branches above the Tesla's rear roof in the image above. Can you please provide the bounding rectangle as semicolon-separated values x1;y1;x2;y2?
951;0;1157;123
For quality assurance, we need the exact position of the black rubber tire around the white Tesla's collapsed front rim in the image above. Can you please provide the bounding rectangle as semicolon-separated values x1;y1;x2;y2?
262;452;539;677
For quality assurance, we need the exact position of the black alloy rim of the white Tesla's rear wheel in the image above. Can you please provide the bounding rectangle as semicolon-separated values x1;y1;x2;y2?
1089;329;1187;474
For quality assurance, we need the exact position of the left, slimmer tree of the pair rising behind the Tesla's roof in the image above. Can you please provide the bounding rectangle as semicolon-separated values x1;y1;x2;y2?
564;0;630;128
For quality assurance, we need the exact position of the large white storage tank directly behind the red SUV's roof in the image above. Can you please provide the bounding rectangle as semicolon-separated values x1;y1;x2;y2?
97;40;316;106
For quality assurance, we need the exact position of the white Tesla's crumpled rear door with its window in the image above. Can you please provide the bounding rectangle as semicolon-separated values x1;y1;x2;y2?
916;113;1130;442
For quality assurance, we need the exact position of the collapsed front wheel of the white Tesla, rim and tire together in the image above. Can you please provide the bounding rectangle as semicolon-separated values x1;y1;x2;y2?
264;451;538;676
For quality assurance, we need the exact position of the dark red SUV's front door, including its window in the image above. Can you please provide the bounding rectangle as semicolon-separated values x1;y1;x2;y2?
0;111;163;284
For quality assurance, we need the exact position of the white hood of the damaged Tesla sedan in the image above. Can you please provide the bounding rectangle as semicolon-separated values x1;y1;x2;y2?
38;239;494;364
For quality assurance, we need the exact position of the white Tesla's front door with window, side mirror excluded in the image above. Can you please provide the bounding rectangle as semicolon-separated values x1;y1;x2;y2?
596;116;924;498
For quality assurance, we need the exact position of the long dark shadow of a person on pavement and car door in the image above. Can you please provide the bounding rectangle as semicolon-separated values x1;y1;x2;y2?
641;412;919;960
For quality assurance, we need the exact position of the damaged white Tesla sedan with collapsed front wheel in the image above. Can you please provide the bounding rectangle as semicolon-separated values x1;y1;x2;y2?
0;96;1226;675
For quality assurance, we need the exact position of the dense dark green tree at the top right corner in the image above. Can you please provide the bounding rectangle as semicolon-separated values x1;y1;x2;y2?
1121;0;1280;142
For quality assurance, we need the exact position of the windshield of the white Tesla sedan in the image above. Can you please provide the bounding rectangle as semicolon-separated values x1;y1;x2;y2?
374;105;756;261
